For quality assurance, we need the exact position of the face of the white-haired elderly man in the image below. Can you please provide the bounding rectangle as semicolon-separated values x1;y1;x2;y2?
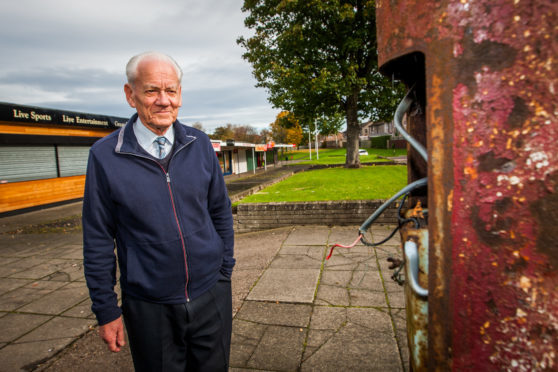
124;59;182;135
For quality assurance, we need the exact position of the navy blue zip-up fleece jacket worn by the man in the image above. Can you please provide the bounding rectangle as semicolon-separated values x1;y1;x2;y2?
83;114;235;325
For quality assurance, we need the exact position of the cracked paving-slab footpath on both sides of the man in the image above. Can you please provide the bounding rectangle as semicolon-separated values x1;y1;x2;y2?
0;163;409;372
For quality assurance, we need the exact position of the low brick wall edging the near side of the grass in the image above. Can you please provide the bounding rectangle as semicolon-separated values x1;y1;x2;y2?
234;200;398;233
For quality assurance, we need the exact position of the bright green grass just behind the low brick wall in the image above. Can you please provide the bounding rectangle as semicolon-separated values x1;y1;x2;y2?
240;165;407;203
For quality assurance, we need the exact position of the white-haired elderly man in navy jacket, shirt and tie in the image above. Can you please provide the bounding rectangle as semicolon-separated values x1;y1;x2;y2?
83;52;235;371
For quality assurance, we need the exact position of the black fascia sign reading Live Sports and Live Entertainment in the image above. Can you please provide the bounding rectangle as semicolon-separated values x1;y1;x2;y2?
0;102;128;128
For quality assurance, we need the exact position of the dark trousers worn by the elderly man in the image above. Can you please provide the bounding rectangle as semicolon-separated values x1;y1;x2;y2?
122;277;232;372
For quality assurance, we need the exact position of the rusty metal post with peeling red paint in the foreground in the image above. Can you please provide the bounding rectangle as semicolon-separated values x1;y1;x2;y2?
376;0;558;371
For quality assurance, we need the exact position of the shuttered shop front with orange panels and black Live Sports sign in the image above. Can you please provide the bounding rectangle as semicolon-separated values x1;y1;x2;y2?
0;103;127;215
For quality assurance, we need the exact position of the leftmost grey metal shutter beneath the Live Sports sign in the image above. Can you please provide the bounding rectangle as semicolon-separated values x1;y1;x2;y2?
0;145;57;183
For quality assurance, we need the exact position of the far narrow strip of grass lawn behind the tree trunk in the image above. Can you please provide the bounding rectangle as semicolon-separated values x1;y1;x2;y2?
287;149;407;164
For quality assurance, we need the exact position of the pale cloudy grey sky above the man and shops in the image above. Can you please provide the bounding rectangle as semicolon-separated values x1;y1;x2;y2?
0;0;279;133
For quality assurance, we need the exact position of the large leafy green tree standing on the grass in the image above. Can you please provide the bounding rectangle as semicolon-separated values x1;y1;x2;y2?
237;0;402;167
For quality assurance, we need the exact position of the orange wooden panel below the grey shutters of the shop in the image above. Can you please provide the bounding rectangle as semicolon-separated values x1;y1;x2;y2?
0;176;85;213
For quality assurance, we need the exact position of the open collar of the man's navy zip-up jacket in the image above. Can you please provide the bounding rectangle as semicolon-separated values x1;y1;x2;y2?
114;113;197;155
